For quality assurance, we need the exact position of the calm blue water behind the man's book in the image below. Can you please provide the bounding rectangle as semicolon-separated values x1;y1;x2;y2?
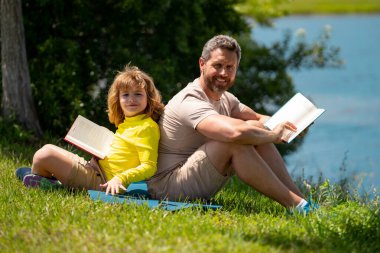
252;15;380;191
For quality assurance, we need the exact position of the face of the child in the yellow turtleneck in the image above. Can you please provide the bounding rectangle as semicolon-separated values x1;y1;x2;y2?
119;87;148;117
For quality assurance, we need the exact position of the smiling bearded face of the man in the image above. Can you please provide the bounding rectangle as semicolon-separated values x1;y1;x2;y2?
199;48;238;96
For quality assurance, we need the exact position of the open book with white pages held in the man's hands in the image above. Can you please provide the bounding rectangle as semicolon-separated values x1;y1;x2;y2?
264;93;325;143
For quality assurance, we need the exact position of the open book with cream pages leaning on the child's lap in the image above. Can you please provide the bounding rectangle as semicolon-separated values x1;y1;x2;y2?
64;115;114;159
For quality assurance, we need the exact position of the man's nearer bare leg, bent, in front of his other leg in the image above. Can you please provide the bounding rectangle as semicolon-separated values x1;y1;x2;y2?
205;141;302;207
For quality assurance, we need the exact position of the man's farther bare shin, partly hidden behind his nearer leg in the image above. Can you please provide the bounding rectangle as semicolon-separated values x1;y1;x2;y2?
256;143;304;198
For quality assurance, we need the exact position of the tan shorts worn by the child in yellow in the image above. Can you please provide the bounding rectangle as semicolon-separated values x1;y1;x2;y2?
65;154;106;190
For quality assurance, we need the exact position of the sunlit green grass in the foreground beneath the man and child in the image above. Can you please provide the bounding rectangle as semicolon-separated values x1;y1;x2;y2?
0;127;380;252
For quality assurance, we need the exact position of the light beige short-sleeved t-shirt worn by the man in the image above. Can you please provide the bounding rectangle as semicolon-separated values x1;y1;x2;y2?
156;79;245;175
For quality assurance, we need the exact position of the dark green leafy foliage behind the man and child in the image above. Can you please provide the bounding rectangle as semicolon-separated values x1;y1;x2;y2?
22;0;342;142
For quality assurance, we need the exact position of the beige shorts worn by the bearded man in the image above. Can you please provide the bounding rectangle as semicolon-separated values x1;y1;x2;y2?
148;145;232;201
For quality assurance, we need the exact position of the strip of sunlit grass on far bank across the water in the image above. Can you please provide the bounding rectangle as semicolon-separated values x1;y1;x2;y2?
281;0;380;14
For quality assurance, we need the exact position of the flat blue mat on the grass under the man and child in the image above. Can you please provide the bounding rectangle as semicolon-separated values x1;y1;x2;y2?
88;182;222;211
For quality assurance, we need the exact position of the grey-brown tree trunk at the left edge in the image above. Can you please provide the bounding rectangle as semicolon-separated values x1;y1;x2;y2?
0;0;42;137
